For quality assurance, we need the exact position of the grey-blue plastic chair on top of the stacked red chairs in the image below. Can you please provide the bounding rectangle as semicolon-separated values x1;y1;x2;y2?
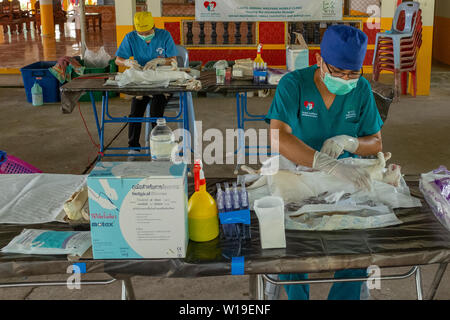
372;1;420;69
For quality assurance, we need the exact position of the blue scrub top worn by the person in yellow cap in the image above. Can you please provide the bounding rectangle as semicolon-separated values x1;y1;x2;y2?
116;28;178;66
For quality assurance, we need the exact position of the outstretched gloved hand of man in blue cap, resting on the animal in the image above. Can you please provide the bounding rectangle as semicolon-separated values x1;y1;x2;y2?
313;151;372;191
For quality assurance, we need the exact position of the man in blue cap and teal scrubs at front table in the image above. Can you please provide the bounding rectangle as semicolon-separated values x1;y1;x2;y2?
266;25;383;300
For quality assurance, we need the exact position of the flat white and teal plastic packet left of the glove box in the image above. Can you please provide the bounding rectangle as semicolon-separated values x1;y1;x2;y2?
1;229;91;257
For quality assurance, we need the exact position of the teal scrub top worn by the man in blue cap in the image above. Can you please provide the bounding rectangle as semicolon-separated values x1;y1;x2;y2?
265;65;383;158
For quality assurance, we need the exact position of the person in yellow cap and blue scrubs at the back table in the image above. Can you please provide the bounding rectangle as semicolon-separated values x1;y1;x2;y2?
116;11;178;160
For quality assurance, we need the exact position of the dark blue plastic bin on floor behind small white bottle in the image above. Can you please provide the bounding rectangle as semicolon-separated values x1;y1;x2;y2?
20;61;61;103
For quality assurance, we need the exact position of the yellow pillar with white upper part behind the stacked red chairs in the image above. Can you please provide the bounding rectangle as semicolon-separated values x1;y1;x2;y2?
381;0;435;95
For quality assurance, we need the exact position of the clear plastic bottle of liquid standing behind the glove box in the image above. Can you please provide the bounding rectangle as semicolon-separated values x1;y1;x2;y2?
150;118;175;161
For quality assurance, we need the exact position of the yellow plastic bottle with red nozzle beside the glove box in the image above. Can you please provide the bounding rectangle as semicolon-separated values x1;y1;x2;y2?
188;160;219;242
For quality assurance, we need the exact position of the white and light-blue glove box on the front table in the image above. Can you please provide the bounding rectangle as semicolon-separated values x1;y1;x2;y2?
87;161;189;259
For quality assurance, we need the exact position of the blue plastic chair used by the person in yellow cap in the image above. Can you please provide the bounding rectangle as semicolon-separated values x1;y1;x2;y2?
145;45;196;152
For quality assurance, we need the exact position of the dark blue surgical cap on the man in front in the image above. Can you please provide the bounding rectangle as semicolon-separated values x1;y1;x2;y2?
320;25;367;70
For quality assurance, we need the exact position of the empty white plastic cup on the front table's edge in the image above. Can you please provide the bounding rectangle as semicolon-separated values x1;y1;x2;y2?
254;196;286;249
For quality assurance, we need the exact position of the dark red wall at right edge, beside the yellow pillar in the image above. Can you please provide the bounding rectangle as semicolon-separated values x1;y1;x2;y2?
433;0;450;65
